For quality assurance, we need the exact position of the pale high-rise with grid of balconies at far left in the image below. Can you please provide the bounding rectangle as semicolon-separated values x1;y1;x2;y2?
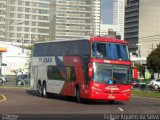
0;0;50;43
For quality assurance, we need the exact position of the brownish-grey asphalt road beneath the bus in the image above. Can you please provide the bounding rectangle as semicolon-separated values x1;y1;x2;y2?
0;88;160;120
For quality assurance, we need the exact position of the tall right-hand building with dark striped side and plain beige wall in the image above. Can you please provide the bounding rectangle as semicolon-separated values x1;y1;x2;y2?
125;0;160;58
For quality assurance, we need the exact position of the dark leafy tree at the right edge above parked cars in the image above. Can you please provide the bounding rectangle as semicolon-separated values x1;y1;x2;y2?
147;44;160;73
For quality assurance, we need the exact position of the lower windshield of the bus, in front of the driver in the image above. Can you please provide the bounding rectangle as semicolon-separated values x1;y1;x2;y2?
93;64;130;84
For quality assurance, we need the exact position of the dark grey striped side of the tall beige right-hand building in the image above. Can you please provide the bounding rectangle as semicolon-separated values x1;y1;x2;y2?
124;0;139;54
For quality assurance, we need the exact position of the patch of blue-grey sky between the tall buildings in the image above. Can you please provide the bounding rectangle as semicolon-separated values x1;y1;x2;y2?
101;0;113;24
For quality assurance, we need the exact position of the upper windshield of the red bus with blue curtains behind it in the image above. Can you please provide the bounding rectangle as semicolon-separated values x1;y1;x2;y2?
92;42;129;60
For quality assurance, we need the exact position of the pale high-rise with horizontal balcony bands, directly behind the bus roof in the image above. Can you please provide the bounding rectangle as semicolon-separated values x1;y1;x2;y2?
50;0;100;39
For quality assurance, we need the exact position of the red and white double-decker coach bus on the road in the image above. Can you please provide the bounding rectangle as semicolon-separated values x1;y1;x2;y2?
31;37;131;103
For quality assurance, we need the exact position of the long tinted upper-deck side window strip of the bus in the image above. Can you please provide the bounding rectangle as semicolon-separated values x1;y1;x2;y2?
33;40;91;57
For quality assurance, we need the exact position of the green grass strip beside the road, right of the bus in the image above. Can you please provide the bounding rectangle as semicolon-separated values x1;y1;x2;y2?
131;90;160;99
